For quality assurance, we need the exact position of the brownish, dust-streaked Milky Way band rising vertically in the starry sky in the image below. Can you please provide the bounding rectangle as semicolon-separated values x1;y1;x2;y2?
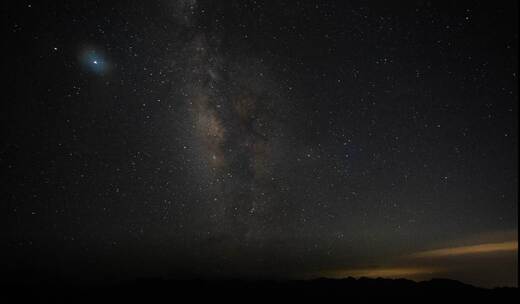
179;34;283;245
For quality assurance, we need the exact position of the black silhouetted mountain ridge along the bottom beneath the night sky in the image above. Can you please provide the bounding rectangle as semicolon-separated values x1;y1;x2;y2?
3;278;518;303
